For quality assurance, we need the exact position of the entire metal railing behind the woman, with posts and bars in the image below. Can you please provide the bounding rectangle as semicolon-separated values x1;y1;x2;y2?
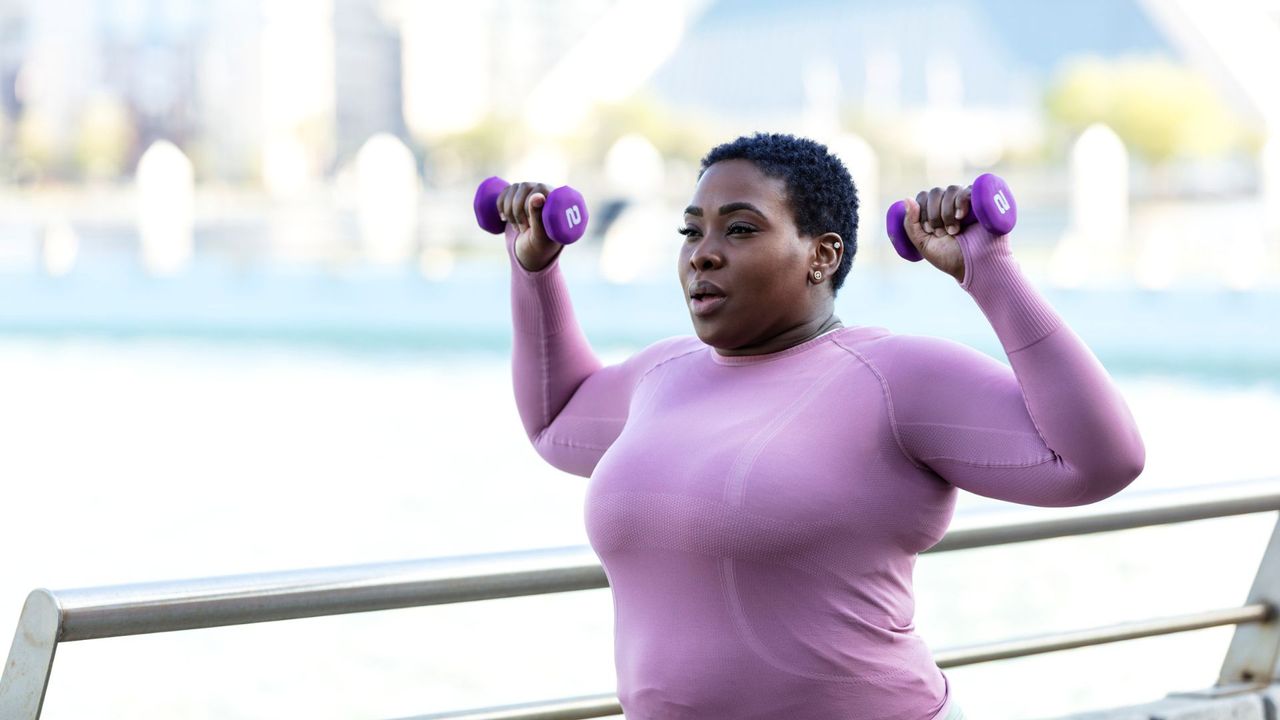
0;479;1280;720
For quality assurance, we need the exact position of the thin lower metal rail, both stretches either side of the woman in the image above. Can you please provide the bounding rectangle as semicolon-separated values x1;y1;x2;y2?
404;605;1274;720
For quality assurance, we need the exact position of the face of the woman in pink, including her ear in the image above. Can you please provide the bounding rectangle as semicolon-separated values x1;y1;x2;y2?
678;160;831;352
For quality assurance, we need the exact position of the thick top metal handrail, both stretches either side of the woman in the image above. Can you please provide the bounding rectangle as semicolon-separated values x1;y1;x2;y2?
40;480;1280;642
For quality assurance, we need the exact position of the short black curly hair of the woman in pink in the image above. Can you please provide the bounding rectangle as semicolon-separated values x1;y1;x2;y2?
698;132;858;292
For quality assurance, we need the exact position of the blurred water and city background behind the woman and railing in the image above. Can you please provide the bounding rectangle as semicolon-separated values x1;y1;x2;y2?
0;0;1280;720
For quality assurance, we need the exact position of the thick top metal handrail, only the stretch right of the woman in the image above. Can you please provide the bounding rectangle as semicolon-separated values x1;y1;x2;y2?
925;479;1280;552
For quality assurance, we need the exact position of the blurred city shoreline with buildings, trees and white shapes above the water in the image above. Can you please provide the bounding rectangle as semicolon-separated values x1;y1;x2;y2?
0;0;1280;290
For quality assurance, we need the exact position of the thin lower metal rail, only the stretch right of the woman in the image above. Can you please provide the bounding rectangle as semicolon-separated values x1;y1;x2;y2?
933;603;1272;669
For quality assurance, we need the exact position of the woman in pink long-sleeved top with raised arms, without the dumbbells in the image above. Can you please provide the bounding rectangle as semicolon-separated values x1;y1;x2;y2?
498;135;1144;720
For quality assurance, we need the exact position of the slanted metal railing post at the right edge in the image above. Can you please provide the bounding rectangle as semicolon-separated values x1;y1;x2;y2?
1217;518;1280;685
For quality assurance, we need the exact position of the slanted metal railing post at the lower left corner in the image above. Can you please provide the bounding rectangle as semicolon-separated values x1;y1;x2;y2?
0;589;63;720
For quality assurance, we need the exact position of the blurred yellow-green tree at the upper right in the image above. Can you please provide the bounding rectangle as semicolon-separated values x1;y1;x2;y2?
1046;58;1258;164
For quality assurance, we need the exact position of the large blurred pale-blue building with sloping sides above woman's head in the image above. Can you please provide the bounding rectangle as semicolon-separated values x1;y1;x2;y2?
653;0;1171;118
